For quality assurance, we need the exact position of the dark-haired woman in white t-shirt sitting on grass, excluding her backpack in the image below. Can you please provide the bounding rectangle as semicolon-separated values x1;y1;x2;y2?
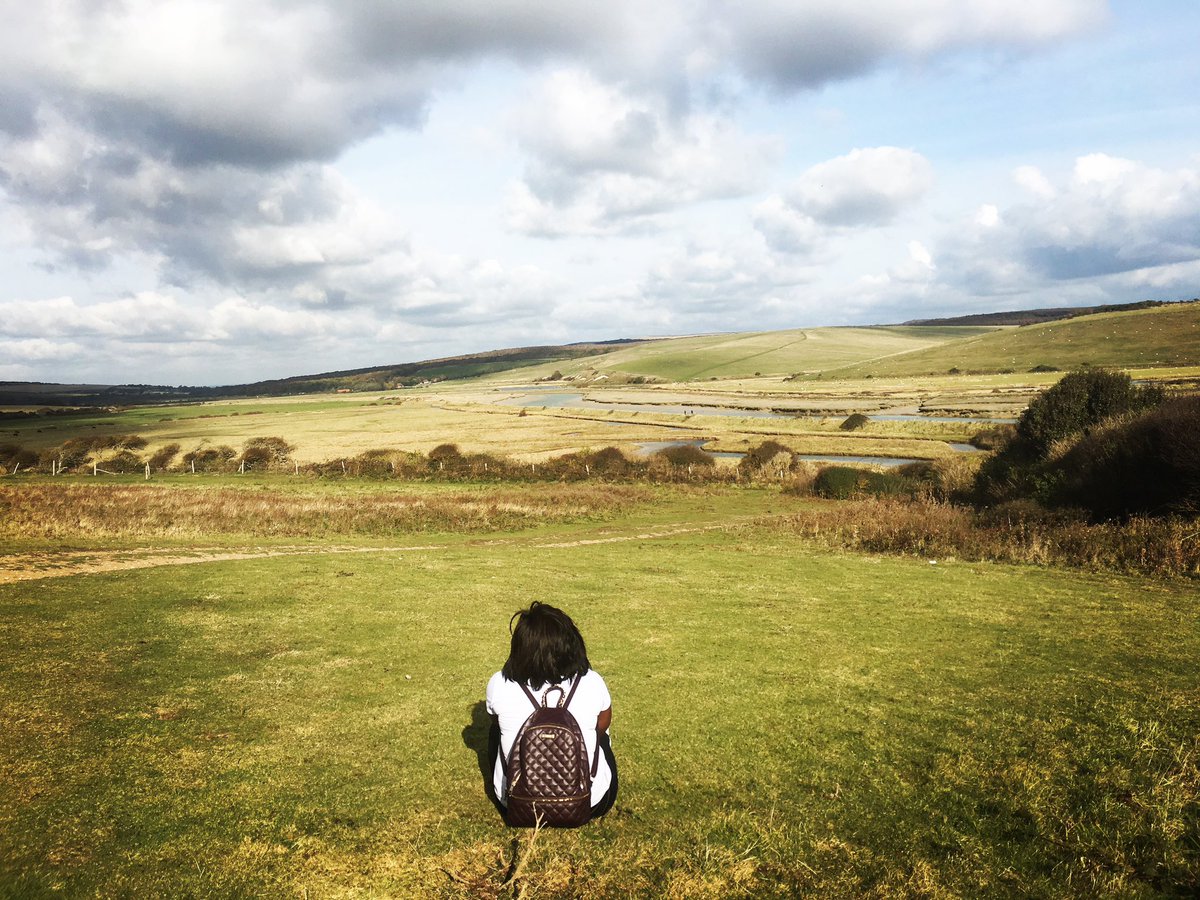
487;602;617;818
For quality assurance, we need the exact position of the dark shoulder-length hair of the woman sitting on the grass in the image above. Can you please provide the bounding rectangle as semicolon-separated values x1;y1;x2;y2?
500;601;592;690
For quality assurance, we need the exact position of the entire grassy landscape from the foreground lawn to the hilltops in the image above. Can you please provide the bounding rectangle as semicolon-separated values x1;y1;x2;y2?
0;305;1200;899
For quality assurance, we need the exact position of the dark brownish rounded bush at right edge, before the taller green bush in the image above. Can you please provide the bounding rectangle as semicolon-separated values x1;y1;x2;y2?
1049;396;1200;521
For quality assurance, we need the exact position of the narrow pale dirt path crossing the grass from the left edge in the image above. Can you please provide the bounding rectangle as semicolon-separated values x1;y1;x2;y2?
0;521;736;584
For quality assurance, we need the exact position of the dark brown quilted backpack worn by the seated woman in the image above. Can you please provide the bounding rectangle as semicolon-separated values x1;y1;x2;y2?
505;676;600;828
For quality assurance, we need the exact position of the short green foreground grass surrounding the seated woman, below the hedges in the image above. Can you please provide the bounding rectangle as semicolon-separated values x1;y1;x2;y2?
0;485;1200;898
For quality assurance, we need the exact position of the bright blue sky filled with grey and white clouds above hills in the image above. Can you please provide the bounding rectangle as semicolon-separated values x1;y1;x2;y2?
0;0;1200;385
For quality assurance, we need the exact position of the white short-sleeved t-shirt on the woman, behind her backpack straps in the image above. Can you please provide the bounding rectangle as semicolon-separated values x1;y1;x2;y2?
487;670;612;806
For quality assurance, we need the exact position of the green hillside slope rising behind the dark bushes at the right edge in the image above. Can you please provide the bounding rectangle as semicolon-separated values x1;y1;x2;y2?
826;302;1200;378
